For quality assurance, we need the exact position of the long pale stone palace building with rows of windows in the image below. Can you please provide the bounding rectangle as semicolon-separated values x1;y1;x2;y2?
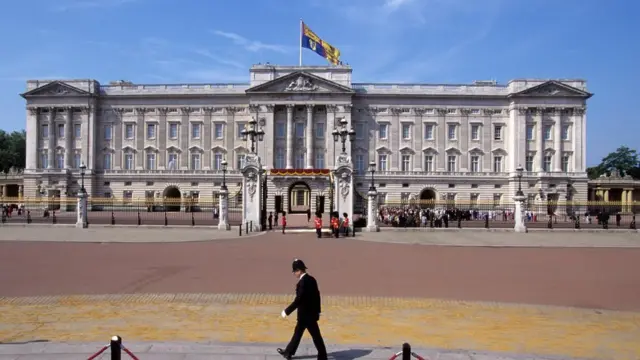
22;64;591;211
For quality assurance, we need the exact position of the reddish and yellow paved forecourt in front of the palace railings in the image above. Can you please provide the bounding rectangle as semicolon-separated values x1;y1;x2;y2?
0;227;640;359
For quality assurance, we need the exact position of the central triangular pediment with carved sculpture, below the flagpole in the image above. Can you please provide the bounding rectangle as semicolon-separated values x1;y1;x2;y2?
246;71;354;94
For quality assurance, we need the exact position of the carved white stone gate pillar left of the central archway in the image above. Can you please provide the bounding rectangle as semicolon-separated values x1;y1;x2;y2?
242;154;263;231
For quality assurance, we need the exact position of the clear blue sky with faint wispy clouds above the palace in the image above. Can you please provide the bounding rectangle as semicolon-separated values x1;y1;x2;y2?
0;0;640;165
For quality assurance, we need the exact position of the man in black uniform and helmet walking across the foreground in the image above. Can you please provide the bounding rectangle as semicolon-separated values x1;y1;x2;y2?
278;259;327;360
